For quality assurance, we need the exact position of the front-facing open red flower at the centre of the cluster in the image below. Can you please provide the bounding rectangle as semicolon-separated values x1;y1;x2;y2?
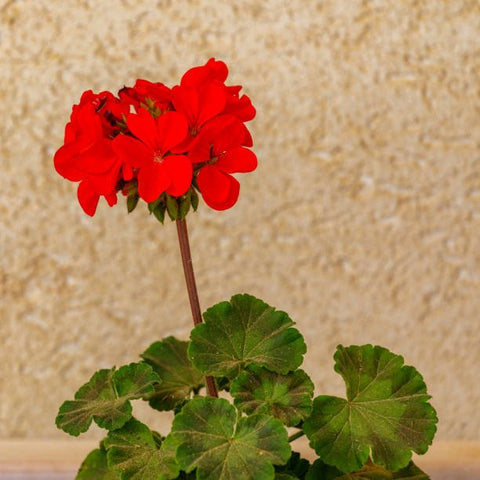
113;108;192;202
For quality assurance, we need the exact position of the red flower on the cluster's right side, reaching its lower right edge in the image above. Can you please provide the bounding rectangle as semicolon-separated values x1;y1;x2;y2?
188;115;257;210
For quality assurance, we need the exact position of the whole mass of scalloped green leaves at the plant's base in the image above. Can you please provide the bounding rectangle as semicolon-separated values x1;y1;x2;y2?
57;296;437;480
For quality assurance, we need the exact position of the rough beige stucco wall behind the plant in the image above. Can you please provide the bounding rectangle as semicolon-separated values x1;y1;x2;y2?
0;0;480;439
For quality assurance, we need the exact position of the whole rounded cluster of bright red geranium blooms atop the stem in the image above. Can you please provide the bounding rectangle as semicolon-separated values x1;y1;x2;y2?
54;58;257;215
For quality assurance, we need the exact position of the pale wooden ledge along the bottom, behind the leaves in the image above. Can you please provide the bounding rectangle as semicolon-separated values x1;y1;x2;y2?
0;439;480;480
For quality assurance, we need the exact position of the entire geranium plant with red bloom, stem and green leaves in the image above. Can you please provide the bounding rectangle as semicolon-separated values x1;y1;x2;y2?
54;59;437;480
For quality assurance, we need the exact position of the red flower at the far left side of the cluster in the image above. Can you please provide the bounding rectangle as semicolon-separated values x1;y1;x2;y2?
54;90;125;215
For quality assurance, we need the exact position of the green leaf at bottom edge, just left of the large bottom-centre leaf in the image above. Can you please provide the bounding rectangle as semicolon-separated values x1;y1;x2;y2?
104;418;180;480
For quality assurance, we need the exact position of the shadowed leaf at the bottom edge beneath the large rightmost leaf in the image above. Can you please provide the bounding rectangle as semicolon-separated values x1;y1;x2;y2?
305;460;430;480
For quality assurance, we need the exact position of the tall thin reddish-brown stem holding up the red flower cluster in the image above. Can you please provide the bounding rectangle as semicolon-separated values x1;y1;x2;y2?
176;219;218;397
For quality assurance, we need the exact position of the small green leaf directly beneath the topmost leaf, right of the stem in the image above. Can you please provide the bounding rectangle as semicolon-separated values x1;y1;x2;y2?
230;365;314;427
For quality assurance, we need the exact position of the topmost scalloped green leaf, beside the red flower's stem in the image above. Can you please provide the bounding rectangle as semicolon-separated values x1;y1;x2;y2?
188;295;306;378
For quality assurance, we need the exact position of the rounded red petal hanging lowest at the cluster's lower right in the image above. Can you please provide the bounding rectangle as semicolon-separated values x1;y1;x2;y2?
197;165;240;210
